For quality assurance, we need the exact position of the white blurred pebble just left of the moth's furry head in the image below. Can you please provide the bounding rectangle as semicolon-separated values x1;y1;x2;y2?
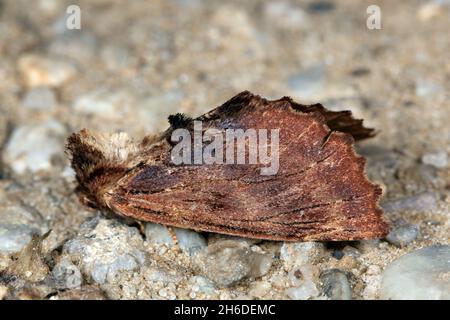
4;120;66;175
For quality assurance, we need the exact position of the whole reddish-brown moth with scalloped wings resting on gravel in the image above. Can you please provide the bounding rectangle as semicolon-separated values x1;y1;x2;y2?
67;92;388;241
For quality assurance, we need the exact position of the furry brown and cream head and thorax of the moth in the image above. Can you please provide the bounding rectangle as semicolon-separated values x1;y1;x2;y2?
67;129;139;208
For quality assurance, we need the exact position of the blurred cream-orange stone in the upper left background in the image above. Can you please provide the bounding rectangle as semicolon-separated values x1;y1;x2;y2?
18;54;76;87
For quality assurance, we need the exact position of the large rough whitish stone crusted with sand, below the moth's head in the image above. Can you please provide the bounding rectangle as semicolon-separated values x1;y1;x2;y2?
63;217;146;284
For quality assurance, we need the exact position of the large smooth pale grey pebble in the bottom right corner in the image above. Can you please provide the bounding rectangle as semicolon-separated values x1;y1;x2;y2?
380;245;450;300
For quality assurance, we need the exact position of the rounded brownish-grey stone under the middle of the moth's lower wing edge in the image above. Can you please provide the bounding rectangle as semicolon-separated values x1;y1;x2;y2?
193;240;252;287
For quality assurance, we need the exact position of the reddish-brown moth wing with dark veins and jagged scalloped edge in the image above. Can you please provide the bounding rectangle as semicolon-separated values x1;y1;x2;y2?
106;93;388;241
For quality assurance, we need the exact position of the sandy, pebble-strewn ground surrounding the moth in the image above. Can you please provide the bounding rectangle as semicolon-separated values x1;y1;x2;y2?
0;0;450;299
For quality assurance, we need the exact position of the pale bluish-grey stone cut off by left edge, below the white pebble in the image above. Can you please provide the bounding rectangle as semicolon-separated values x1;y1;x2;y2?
0;224;39;254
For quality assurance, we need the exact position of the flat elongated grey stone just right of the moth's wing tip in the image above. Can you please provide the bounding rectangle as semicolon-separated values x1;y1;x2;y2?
381;191;437;213
